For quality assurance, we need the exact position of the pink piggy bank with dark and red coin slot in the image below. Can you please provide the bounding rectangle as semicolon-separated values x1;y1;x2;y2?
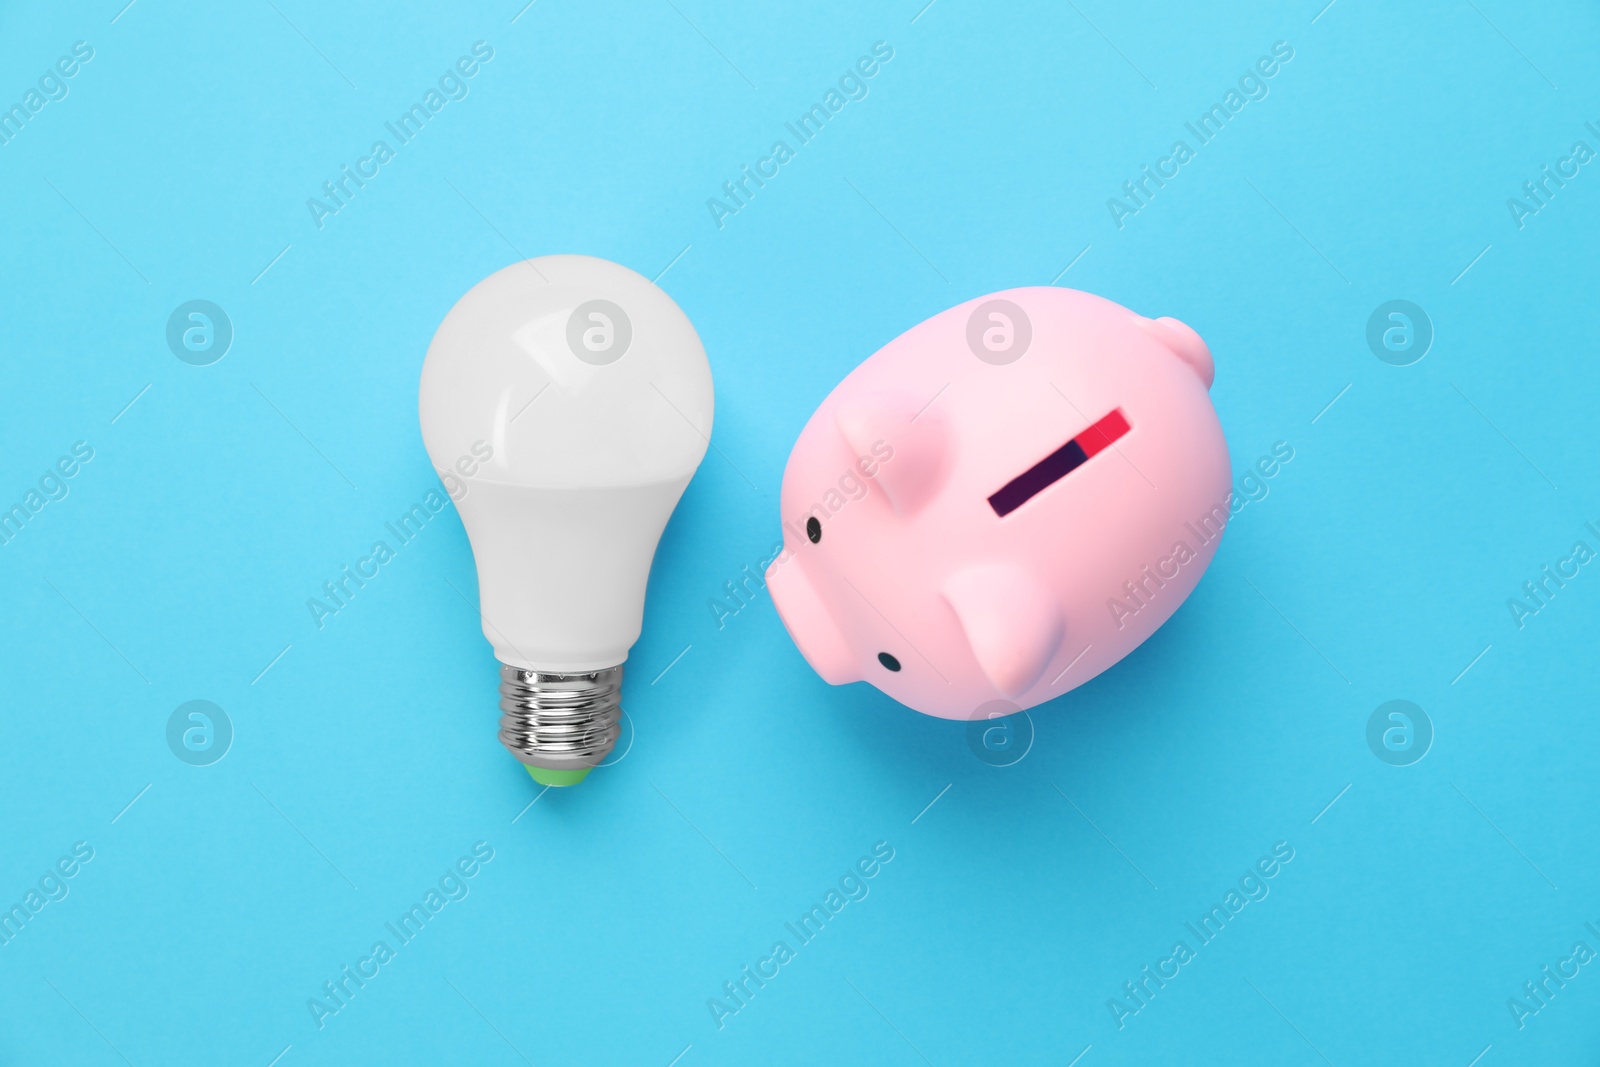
766;286;1232;718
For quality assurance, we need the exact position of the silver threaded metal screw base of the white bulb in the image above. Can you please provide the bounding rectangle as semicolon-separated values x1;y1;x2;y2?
499;664;622;771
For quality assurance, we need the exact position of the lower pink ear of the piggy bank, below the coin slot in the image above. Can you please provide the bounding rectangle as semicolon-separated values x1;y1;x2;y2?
941;563;1067;696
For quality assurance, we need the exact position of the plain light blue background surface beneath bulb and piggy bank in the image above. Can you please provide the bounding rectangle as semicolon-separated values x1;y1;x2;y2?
0;0;1600;1067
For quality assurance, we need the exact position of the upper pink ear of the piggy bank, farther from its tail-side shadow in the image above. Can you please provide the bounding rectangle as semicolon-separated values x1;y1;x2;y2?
834;389;950;515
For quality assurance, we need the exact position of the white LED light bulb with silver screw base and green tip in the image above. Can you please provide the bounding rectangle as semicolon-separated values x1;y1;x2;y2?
418;256;712;785
